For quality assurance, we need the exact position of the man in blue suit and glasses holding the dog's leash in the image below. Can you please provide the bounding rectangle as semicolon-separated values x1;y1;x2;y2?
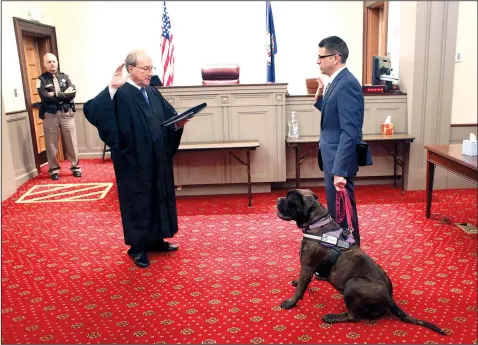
315;36;364;277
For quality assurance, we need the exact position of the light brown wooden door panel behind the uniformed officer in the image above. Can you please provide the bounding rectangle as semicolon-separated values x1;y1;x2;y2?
23;35;63;165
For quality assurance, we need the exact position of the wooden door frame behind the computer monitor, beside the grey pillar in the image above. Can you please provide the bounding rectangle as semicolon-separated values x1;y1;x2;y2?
362;0;388;85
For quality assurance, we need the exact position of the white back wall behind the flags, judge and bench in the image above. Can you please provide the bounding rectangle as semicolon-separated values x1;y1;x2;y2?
2;1;363;112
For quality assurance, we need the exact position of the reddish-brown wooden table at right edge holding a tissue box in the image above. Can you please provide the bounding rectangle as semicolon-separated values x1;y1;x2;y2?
425;144;478;218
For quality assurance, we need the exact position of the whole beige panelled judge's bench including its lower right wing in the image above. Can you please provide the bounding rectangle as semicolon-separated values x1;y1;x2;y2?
154;83;413;195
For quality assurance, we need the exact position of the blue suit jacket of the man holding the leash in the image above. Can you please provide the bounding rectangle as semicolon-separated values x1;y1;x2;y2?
315;68;364;177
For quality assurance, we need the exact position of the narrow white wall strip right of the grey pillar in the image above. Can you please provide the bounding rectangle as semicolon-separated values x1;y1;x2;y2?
451;1;477;124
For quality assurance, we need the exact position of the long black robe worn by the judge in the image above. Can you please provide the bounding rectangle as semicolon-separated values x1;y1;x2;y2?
83;83;183;247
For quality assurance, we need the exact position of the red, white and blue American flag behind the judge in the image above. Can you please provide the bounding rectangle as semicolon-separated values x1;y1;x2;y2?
160;1;174;86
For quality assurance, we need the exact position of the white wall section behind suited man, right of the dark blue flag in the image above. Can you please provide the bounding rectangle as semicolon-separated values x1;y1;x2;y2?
270;1;363;95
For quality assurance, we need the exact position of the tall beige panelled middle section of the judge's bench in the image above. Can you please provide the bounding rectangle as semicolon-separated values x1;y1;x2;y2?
158;83;287;188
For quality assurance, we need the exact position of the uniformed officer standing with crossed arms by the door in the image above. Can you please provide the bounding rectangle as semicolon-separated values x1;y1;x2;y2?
37;53;81;180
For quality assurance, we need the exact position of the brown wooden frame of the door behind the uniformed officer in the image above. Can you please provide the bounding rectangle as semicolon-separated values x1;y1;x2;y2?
13;17;64;174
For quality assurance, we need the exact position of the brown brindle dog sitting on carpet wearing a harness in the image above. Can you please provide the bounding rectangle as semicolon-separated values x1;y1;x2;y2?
277;189;446;335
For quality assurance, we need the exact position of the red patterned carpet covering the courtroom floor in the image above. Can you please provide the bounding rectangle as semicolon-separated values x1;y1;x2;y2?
1;160;477;344
